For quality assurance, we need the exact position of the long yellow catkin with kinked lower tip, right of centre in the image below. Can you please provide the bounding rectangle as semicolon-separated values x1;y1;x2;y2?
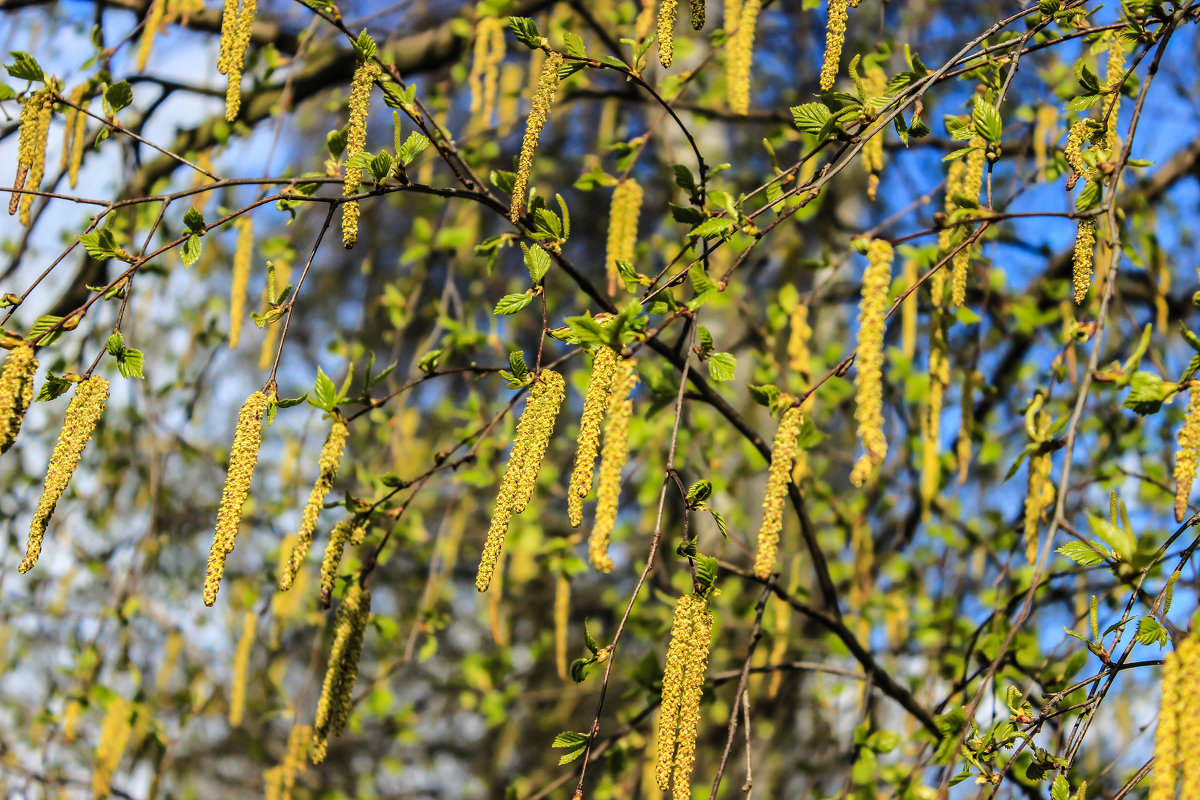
850;239;894;486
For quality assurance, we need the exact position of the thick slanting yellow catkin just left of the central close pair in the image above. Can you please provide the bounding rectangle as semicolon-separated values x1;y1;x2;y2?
475;369;566;591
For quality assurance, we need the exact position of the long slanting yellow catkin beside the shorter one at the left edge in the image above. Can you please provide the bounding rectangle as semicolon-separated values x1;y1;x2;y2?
17;375;108;572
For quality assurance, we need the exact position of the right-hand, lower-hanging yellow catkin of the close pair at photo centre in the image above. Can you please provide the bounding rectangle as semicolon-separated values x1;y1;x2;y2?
588;359;637;572
